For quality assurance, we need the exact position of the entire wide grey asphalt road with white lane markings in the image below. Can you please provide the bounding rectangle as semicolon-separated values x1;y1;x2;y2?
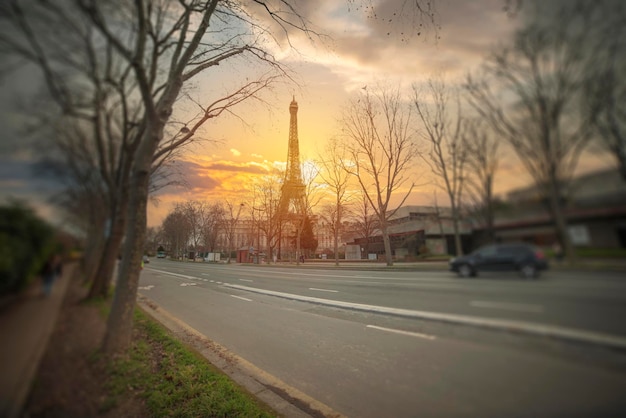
140;259;626;417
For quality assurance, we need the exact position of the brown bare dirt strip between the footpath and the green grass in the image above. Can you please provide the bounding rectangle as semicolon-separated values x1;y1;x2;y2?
24;280;148;418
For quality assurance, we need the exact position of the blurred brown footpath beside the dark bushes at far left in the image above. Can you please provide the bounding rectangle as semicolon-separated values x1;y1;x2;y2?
0;263;76;418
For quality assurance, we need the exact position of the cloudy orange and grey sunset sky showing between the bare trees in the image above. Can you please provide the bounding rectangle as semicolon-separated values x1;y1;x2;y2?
0;0;616;226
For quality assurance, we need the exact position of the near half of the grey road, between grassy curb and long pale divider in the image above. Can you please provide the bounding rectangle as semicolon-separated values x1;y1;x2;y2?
141;270;626;417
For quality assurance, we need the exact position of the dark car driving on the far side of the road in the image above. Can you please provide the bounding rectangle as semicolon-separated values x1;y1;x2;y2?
450;244;548;279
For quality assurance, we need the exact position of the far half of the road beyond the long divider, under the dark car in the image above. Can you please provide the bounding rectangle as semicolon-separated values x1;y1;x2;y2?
143;262;626;336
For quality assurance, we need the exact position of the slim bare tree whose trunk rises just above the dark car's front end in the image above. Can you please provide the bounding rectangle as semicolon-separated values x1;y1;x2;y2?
413;79;467;256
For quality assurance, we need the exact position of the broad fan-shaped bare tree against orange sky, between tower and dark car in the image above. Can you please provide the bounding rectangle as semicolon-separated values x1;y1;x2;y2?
342;87;418;266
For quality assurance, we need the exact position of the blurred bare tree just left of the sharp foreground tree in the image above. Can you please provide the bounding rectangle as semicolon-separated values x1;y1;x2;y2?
0;1;141;297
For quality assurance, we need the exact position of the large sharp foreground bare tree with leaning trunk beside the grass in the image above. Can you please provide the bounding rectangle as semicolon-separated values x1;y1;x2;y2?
78;0;304;353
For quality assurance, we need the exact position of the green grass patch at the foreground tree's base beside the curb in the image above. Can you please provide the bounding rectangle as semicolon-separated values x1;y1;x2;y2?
101;310;273;417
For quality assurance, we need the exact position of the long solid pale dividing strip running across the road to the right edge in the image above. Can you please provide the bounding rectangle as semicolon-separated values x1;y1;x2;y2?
223;284;626;351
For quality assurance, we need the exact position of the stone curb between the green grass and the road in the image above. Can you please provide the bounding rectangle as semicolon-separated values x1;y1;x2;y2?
137;293;344;418
